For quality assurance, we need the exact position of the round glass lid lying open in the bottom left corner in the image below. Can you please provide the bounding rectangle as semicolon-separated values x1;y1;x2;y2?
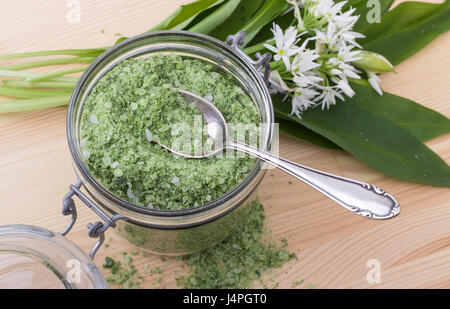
0;225;107;289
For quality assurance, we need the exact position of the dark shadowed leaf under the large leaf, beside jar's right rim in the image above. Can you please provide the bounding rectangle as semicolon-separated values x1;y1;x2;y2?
275;114;341;149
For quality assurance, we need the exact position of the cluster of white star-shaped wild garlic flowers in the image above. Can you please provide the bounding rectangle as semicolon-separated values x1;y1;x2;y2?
264;0;392;118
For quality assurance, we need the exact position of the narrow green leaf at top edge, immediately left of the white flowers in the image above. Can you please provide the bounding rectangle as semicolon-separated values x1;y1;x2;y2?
242;0;290;46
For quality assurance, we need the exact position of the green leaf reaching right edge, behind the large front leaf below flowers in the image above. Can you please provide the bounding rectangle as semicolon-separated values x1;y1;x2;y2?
351;84;450;142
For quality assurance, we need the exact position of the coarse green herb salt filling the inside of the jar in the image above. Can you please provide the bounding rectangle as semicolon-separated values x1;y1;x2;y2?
81;54;260;210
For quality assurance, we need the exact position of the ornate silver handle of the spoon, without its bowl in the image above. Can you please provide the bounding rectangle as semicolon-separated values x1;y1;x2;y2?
226;140;400;219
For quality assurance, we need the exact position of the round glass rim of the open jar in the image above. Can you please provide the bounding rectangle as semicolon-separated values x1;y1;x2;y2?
66;30;274;217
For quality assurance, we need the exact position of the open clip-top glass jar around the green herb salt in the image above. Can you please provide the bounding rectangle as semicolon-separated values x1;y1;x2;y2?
65;31;274;256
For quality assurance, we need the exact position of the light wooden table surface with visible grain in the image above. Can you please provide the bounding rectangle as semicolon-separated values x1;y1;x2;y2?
0;0;450;288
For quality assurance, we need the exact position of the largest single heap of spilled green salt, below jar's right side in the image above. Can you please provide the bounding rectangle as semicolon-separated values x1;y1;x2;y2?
177;201;295;289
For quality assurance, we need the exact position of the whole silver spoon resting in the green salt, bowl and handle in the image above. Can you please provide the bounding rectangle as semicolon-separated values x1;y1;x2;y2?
159;88;400;219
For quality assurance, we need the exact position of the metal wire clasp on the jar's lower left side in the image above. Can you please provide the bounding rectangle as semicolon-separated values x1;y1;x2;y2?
60;178;125;260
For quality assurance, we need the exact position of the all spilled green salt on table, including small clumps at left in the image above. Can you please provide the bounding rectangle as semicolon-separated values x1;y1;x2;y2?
103;201;296;289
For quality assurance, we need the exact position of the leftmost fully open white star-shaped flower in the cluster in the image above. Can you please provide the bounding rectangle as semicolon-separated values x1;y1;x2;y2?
264;24;297;70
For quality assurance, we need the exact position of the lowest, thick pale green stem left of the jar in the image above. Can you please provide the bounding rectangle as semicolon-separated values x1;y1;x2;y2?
0;94;70;113
